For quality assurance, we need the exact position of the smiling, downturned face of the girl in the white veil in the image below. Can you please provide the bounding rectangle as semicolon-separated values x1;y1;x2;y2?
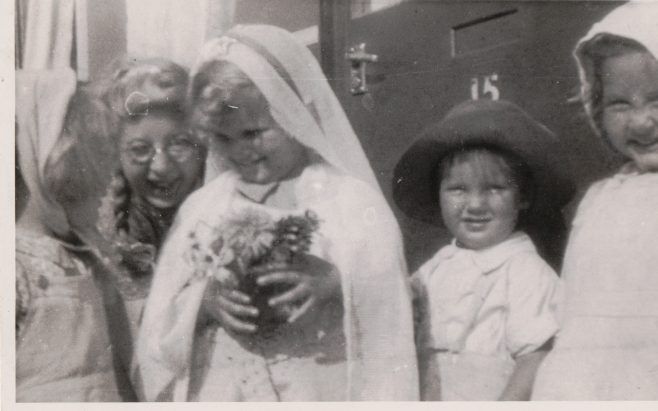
206;87;308;184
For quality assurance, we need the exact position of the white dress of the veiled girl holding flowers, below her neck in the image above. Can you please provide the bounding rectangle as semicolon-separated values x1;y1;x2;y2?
137;162;418;401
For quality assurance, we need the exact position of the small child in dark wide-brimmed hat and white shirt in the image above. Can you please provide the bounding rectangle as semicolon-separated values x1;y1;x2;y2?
394;100;573;400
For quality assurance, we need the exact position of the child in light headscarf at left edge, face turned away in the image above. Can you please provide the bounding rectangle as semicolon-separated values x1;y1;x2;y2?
15;68;136;402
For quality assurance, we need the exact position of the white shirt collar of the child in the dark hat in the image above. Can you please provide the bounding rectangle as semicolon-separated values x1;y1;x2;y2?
441;231;537;274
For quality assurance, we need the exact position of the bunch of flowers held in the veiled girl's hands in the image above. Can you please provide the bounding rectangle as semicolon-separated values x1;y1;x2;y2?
186;208;320;329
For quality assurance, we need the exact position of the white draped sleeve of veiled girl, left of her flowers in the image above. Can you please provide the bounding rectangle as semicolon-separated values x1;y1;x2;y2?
132;178;229;401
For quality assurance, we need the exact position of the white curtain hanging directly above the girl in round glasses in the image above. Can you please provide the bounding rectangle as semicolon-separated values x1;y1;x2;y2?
126;0;237;68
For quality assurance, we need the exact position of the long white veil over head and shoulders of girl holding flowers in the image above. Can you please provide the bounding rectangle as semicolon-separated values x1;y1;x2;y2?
134;25;418;401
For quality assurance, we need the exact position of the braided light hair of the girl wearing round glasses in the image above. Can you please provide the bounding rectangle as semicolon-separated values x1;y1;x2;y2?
97;58;206;277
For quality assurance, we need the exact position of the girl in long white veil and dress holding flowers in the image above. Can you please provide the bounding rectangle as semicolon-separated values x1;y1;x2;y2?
135;25;418;401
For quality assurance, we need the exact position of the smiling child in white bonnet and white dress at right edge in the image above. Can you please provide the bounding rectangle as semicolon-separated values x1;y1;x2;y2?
532;2;658;401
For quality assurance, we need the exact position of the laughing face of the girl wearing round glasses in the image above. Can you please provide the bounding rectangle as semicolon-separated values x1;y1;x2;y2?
121;113;203;209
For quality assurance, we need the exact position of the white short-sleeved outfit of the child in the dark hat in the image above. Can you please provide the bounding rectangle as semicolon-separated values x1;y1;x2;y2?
412;232;559;401
